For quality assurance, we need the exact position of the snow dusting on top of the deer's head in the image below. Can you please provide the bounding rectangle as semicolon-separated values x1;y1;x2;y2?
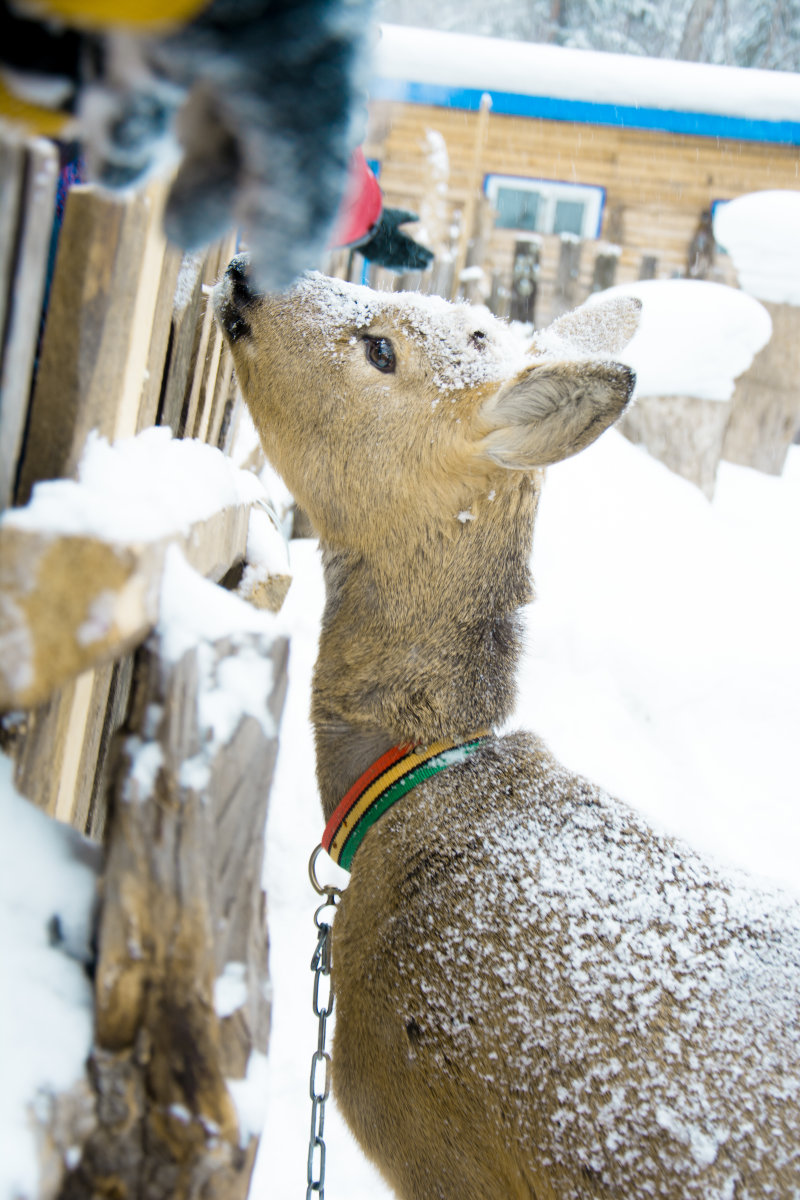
297;272;530;394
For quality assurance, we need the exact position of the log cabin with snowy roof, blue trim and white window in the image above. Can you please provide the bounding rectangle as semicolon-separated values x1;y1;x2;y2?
366;25;800;324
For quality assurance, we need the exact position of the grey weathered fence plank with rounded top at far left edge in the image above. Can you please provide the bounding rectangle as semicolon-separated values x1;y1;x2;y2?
0;138;59;510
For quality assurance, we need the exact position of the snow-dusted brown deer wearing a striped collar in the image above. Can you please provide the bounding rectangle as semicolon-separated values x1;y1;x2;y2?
213;256;800;1200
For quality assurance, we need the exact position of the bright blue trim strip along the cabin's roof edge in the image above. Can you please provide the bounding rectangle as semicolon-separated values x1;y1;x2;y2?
369;79;800;145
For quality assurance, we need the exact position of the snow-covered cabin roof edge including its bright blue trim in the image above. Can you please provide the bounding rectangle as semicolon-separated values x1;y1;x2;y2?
371;25;800;144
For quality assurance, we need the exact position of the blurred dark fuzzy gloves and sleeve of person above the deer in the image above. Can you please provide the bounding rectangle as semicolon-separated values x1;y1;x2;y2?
0;0;373;289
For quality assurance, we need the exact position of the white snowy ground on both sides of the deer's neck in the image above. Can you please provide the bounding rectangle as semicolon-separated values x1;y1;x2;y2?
251;431;800;1200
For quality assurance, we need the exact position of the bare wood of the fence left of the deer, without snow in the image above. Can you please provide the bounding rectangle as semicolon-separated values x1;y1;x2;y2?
0;128;287;1200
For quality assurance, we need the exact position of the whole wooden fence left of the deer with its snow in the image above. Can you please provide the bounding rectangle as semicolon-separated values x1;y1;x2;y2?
0;124;288;1198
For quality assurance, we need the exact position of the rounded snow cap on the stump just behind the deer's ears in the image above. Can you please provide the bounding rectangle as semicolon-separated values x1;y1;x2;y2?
588;280;772;401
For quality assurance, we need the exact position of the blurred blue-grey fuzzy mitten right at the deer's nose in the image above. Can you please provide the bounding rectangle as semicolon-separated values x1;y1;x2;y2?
151;0;372;288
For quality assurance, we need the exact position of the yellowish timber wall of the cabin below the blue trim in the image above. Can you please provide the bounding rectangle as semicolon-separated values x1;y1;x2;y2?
367;101;800;324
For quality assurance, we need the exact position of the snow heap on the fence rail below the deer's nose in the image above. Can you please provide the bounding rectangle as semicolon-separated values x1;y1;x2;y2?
4;426;264;542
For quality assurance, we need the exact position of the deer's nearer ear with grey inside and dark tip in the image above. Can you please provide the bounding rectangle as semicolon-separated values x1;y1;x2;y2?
482;360;636;470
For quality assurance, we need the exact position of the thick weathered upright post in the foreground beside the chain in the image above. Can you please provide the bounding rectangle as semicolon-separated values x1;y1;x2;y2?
62;566;287;1200
